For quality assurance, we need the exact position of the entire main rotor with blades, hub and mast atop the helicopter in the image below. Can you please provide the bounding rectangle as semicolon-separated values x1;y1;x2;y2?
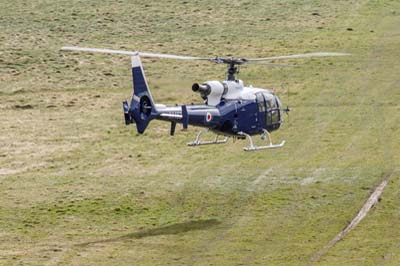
61;46;351;80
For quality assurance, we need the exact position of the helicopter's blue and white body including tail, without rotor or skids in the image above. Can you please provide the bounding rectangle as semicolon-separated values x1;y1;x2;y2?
123;56;282;141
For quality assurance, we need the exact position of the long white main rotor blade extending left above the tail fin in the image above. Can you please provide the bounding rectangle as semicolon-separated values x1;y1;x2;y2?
61;46;213;61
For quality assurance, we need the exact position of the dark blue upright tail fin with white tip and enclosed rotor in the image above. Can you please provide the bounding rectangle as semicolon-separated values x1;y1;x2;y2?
125;55;157;134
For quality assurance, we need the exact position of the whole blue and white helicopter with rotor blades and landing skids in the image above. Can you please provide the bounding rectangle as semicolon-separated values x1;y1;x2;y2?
61;46;350;151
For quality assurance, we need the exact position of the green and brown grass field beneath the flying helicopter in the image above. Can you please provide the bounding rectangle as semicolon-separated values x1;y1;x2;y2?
0;0;400;265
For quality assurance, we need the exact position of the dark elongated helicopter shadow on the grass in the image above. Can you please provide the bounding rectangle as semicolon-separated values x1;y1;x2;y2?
76;219;221;247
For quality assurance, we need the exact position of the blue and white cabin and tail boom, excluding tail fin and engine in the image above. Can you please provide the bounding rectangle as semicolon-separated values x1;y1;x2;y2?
154;87;282;136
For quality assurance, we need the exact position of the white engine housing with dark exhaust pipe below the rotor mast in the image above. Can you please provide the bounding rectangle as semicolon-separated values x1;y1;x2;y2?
192;81;228;106
